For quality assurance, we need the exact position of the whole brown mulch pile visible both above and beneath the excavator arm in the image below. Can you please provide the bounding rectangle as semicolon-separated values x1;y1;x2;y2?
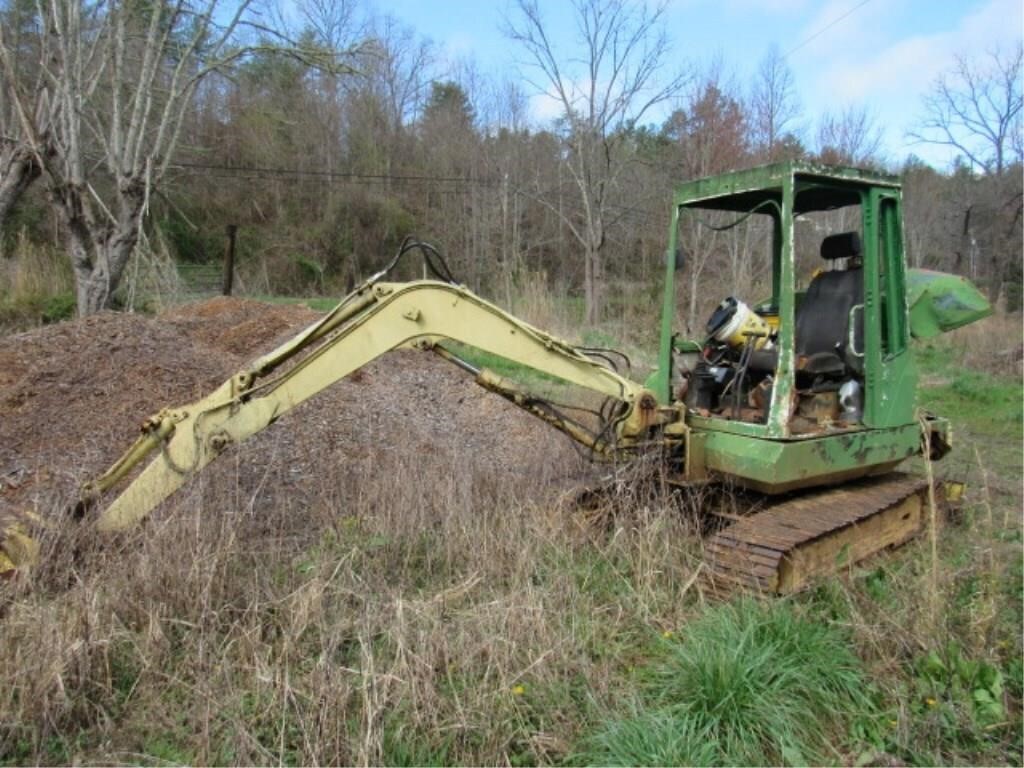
0;298;586;536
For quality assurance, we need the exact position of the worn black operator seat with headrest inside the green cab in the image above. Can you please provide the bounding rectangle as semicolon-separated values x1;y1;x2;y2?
795;232;864;378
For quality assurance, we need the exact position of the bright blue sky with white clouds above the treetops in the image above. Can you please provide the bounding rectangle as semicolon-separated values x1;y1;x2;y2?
364;0;1024;166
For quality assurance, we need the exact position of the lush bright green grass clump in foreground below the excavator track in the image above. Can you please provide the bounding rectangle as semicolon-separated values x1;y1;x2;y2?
586;599;872;765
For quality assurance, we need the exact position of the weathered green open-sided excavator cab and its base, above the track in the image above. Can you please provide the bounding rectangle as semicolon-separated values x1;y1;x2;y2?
649;162;943;493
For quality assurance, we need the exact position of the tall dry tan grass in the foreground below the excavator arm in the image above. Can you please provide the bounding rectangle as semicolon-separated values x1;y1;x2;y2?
0;450;698;764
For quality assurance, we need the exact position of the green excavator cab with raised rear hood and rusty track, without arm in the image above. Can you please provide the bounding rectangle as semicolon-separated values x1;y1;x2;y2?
648;162;989;593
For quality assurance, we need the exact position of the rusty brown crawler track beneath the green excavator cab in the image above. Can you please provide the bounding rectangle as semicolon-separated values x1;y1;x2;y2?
705;473;928;594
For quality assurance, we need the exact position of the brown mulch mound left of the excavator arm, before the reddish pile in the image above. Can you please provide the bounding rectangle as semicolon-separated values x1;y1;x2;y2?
0;312;236;520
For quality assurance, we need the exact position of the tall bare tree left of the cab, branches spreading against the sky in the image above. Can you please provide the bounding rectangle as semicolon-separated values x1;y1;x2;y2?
505;0;684;323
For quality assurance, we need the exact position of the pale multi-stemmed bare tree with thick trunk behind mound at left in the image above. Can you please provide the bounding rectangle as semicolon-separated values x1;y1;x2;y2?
0;0;360;314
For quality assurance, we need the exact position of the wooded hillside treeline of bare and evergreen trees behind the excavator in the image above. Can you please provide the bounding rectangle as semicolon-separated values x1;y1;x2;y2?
0;0;1022;325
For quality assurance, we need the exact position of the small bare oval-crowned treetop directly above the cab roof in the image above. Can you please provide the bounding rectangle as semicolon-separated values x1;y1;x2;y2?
750;45;800;161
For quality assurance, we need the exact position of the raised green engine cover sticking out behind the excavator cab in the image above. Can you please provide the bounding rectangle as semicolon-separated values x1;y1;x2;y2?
906;269;992;339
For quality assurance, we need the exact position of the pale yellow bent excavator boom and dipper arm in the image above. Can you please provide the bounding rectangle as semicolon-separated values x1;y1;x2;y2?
83;280;674;531
